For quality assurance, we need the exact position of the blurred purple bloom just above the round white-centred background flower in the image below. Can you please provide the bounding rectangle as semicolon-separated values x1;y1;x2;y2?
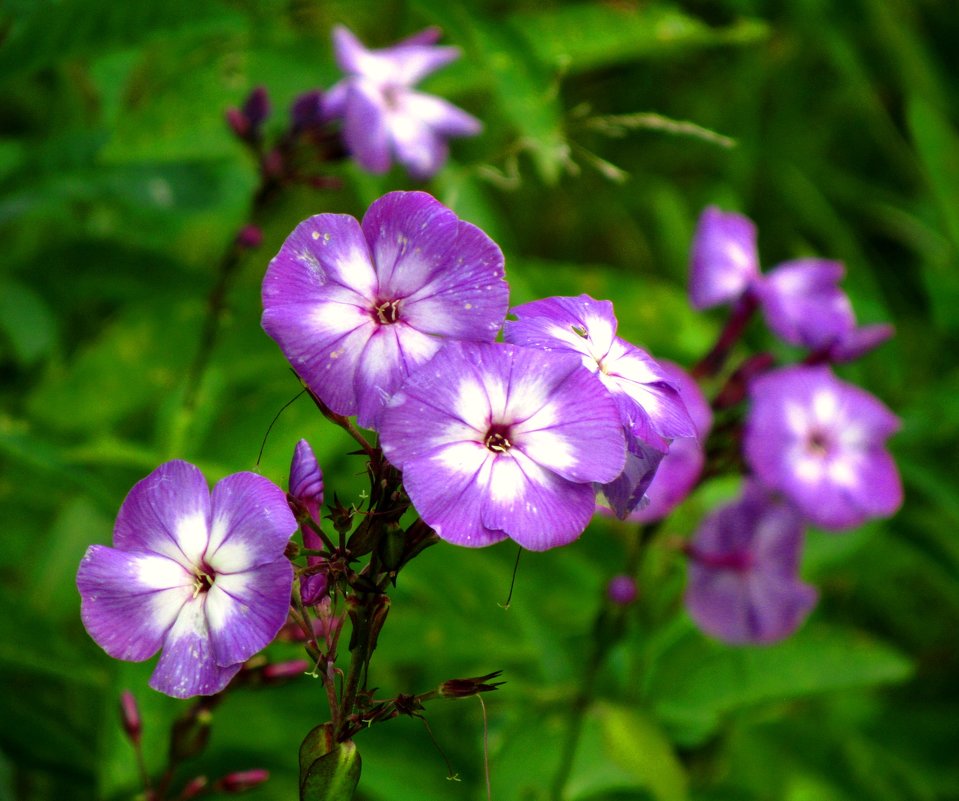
755;259;856;348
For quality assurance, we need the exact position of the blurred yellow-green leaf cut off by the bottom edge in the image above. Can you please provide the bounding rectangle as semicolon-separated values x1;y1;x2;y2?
567;703;686;801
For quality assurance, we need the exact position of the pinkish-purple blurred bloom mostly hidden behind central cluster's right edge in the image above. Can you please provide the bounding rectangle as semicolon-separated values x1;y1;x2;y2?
630;360;713;523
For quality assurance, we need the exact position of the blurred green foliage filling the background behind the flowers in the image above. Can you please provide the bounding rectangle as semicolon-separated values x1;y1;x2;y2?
0;0;959;801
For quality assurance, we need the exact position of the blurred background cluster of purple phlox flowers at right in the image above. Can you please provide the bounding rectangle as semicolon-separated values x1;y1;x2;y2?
680;208;902;642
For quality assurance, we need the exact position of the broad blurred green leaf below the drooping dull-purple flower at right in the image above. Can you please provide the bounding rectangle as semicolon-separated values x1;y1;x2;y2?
646;626;912;744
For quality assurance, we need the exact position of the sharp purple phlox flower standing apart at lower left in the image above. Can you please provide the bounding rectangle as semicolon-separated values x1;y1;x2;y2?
77;461;296;698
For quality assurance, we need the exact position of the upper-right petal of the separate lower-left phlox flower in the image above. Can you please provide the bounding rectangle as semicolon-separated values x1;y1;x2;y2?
206;473;297;580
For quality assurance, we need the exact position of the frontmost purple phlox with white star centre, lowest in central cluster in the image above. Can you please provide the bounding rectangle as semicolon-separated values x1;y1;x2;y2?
380;342;625;551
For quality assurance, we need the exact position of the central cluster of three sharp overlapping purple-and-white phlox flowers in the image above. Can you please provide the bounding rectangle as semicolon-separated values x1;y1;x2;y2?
263;192;695;550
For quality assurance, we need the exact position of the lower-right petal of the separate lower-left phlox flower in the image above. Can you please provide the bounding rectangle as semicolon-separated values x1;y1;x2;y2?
206;558;293;667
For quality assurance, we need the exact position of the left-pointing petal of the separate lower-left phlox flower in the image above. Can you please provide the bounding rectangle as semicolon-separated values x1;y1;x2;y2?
77;545;194;662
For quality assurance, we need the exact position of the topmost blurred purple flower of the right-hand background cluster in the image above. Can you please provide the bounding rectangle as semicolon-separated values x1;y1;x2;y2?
689;206;759;309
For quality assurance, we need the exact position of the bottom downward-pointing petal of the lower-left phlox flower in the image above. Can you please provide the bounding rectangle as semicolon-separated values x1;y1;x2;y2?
150;595;242;698
